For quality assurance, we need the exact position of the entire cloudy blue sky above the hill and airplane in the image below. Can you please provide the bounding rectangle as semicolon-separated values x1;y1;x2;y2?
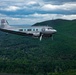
0;0;76;25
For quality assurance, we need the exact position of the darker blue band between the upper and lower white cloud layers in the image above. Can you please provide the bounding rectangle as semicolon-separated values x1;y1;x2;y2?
0;6;76;18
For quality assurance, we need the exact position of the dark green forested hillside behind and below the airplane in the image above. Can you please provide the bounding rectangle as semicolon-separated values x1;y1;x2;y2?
0;19;76;75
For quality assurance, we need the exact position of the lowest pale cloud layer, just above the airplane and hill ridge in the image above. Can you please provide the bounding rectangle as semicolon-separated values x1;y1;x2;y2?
0;13;76;25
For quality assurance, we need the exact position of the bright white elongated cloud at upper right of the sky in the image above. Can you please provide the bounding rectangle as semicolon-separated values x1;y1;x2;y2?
42;3;76;11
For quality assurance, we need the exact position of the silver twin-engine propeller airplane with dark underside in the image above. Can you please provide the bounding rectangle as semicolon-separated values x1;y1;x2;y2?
0;19;57;41
